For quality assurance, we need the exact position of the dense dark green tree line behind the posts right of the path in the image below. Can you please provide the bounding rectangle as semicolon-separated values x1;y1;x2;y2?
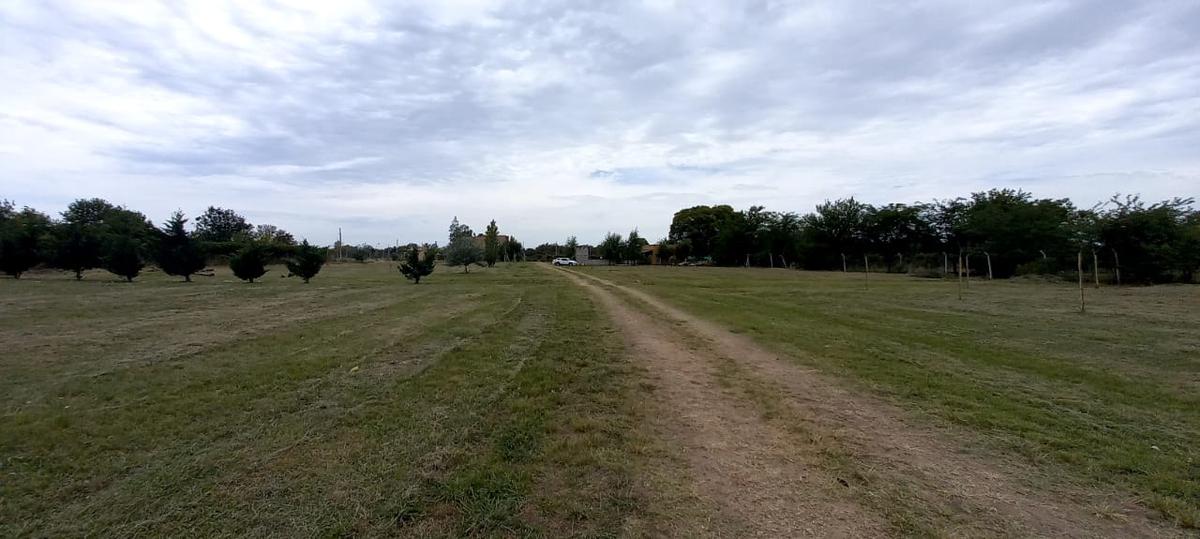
549;188;1200;282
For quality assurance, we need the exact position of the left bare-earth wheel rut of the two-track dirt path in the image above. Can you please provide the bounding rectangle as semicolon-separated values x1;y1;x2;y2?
549;264;886;537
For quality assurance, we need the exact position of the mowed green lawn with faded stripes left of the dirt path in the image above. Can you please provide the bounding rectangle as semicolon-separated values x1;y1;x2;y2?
0;263;642;537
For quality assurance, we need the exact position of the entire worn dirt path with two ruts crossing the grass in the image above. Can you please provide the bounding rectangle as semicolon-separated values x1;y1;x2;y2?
557;265;1183;538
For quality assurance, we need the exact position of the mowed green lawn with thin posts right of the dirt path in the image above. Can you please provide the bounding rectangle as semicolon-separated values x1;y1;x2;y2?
580;266;1200;527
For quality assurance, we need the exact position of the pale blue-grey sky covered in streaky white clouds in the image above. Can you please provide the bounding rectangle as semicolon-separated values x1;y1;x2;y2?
0;0;1200;244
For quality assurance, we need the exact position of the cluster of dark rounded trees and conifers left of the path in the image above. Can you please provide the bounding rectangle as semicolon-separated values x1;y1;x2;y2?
0;198;326;282
